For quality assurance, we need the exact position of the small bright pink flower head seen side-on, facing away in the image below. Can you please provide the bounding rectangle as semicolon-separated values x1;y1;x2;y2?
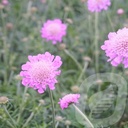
58;94;80;109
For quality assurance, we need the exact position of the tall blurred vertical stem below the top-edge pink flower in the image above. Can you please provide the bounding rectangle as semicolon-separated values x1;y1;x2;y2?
94;12;99;73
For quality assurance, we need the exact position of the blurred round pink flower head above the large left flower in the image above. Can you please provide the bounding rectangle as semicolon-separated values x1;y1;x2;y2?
41;19;67;44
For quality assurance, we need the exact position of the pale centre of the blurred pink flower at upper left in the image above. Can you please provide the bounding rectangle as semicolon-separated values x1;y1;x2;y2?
47;23;60;35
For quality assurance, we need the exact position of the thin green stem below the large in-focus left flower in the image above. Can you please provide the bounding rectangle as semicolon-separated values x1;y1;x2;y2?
48;87;55;128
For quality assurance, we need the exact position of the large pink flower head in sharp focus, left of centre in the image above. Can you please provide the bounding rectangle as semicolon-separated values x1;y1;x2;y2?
20;52;62;93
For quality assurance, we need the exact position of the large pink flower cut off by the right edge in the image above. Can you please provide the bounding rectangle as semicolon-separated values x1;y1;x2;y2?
101;28;128;68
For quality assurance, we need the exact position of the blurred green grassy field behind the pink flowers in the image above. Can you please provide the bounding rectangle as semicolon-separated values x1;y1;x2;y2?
0;0;128;128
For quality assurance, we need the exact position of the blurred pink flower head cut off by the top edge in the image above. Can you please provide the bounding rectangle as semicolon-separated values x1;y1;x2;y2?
87;0;111;12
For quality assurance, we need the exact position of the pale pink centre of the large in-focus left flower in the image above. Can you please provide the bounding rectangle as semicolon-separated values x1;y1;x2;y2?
29;62;51;83
